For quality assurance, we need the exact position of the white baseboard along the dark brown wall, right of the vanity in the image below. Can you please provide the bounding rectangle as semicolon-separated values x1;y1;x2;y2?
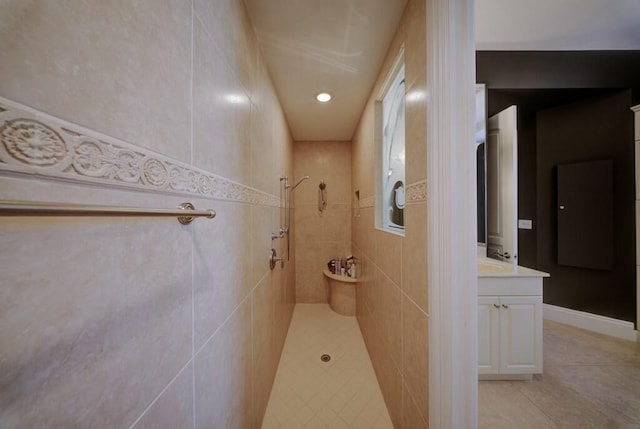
543;304;640;342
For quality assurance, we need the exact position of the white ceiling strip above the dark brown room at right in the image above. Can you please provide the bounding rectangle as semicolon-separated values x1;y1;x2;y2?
476;0;640;51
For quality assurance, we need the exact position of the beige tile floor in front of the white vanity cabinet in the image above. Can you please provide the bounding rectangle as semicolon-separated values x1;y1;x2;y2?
478;320;640;429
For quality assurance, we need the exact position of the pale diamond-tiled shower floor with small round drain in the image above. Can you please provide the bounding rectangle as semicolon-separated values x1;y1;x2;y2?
262;304;393;429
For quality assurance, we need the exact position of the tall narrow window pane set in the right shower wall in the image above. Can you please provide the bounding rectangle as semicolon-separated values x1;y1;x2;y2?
380;64;405;232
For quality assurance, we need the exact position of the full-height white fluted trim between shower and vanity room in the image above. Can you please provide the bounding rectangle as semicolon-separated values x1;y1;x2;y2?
425;0;478;429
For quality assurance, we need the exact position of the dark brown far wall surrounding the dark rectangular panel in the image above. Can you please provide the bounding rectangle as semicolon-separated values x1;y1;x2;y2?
536;91;636;321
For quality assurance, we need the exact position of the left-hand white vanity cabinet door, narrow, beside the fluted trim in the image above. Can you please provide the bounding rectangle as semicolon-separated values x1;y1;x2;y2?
478;296;500;374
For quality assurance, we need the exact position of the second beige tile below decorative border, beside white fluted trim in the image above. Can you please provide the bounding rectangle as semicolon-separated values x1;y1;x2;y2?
402;296;429;420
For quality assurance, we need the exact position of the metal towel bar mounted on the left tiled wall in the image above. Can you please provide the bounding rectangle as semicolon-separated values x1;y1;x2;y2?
0;201;216;225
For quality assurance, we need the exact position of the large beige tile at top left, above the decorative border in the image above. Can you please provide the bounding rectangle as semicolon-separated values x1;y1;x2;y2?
0;0;191;162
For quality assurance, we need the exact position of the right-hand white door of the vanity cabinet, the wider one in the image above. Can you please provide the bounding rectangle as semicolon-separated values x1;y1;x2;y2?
500;296;542;374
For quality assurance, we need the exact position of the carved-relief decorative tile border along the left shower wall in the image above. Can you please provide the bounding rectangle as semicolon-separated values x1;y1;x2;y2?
0;97;280;207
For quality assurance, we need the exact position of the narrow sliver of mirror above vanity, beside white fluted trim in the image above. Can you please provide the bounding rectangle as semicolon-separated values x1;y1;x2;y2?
475;84;487;249
